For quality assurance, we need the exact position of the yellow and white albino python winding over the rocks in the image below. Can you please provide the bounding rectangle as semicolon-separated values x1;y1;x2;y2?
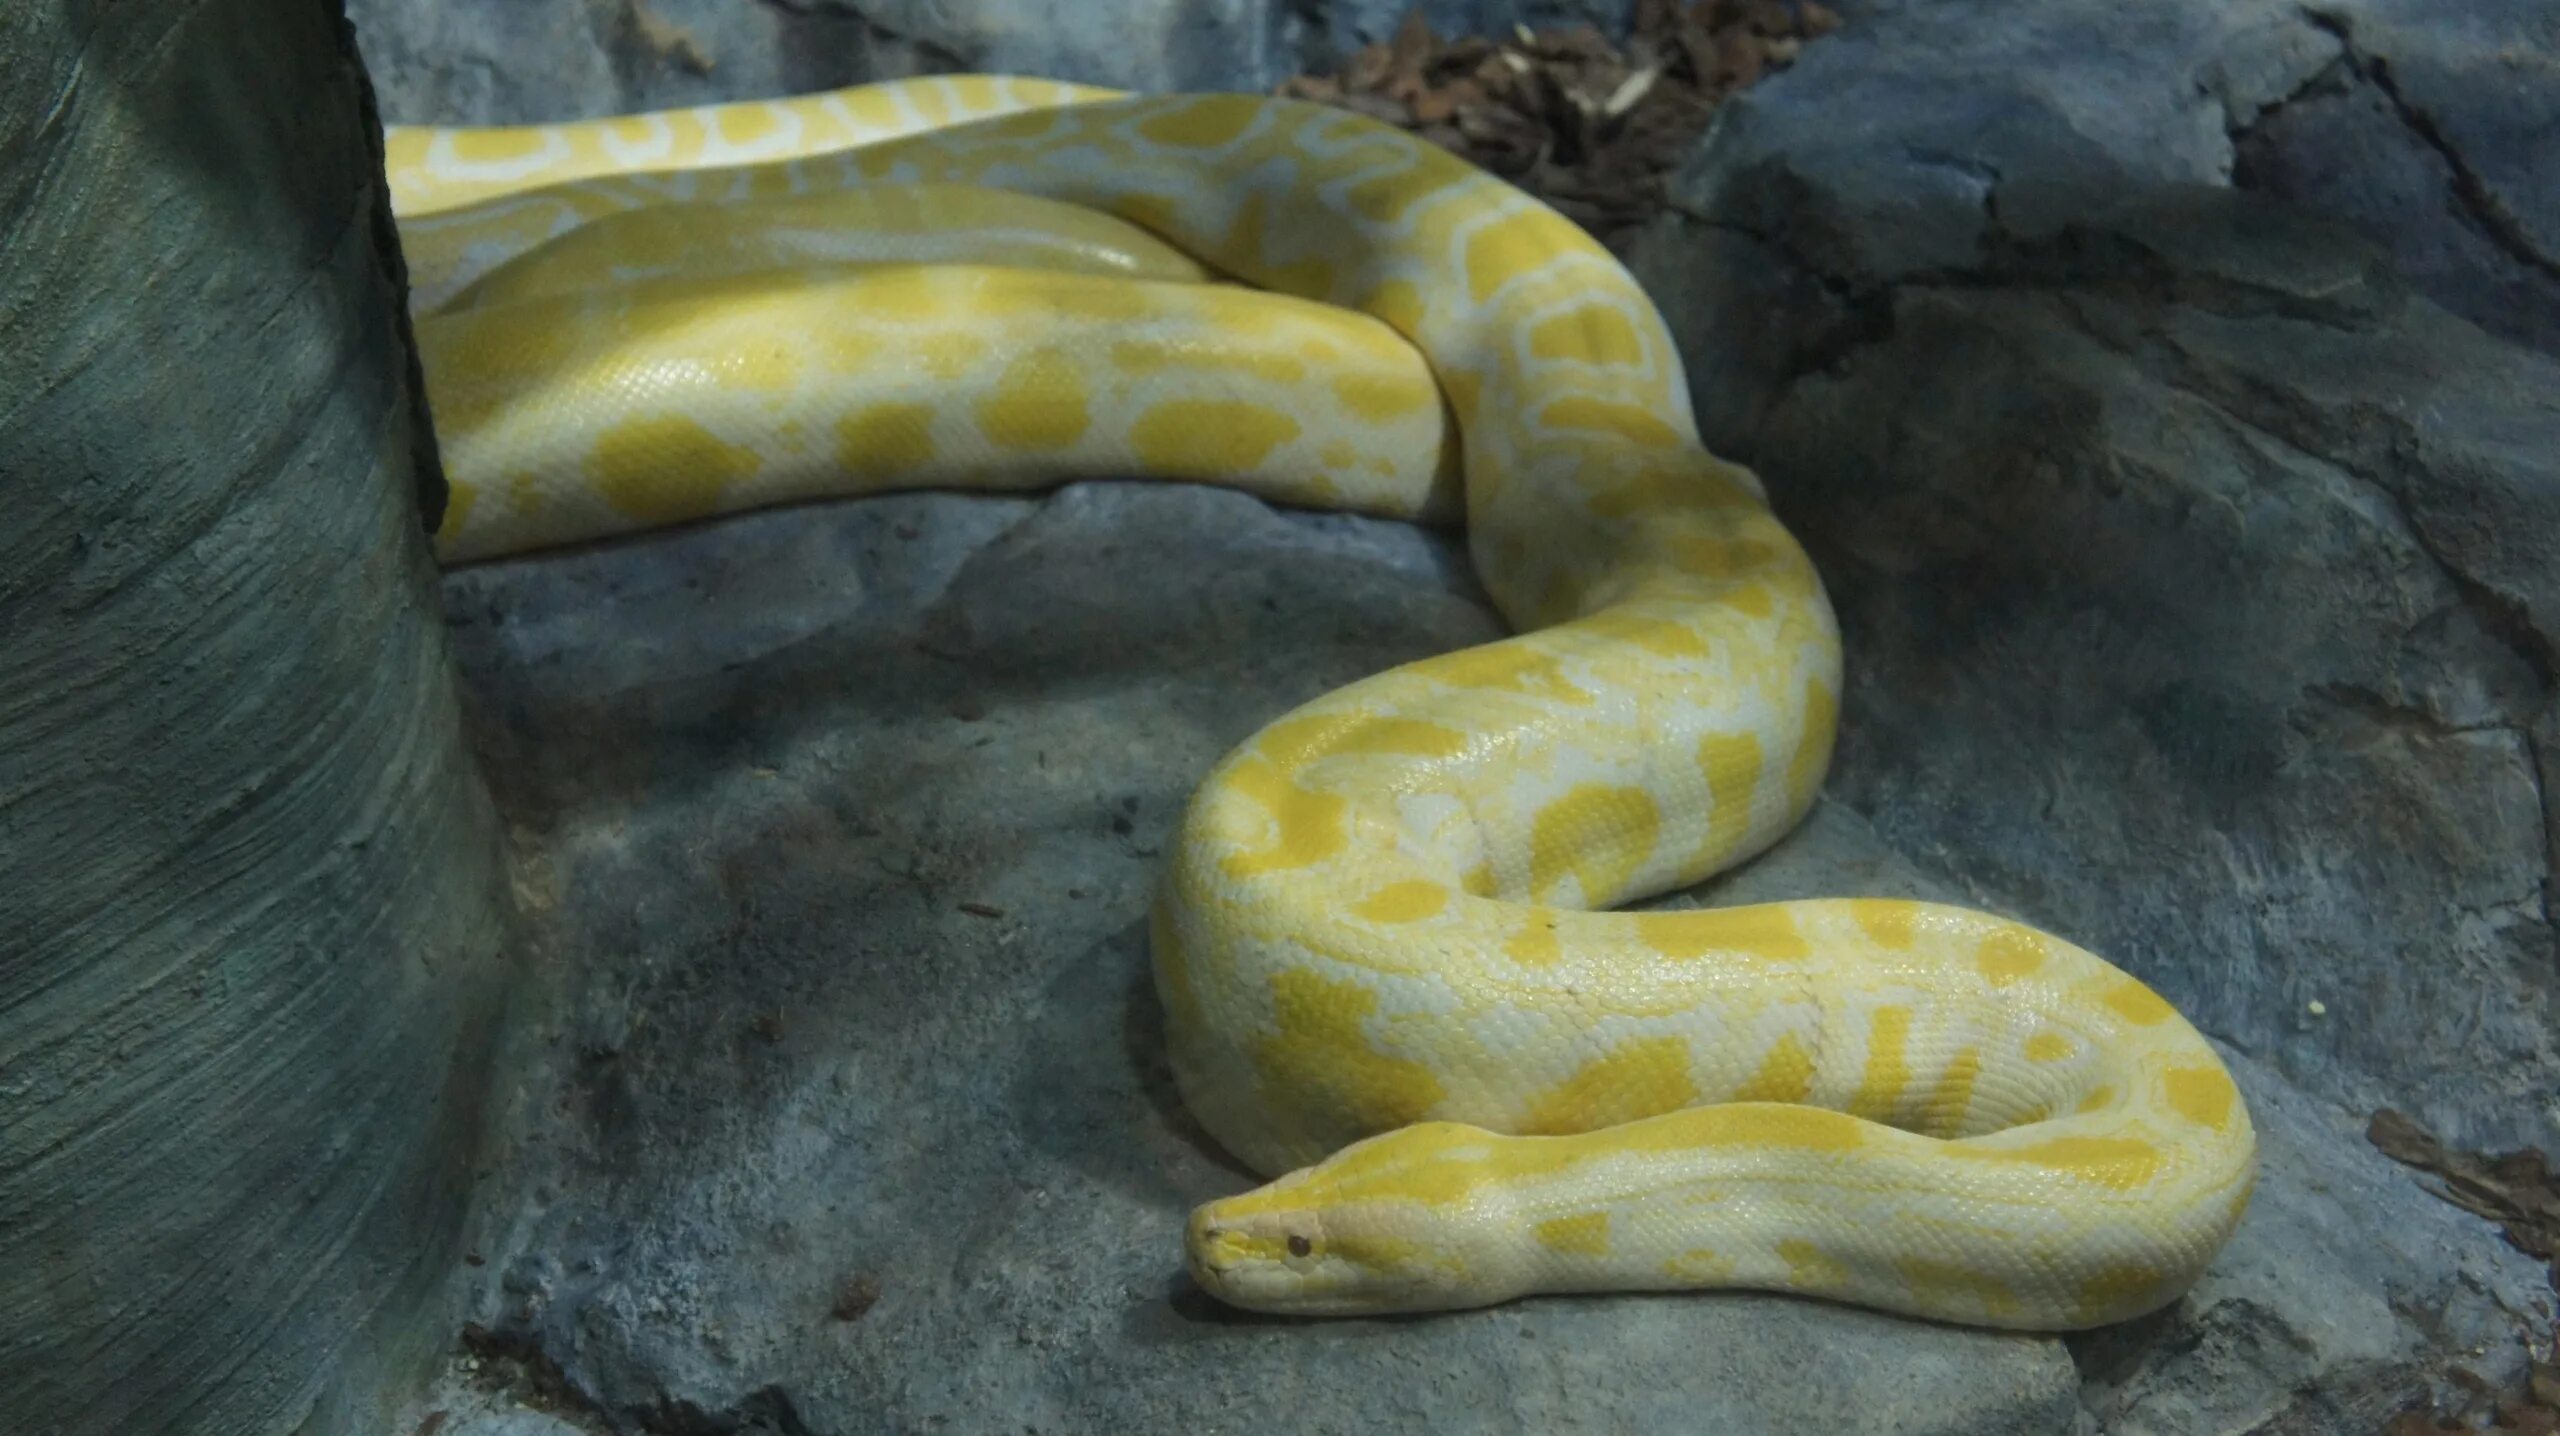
387;77;2255;1331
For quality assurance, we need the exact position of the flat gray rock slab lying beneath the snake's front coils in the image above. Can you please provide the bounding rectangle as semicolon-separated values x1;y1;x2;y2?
399;484;2547;1436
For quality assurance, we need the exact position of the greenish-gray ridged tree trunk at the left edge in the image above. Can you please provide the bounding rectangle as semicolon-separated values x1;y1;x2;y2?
0;0;504;1436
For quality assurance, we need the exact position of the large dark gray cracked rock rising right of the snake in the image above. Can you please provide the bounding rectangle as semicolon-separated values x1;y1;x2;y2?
1638;3;2560;1147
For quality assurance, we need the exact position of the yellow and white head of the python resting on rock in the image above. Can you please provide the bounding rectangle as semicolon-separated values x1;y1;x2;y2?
1183;1124;1526;1316
